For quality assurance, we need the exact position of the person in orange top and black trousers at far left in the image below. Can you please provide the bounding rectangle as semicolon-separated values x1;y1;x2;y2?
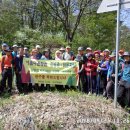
0;48;15;93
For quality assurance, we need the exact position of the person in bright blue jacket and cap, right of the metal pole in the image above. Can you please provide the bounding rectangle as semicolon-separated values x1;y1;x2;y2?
117;52;130;107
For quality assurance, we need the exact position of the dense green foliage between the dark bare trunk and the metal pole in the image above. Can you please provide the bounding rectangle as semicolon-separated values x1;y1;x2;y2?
72;13;116;50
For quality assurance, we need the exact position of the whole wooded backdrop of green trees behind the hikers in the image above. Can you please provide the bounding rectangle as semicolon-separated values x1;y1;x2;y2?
0;0;130;50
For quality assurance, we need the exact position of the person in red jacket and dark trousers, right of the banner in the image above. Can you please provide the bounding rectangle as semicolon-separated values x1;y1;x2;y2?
84;53;97;93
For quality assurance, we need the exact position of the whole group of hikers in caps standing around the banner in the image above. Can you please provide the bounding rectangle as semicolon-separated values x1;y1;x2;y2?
0;43;130;107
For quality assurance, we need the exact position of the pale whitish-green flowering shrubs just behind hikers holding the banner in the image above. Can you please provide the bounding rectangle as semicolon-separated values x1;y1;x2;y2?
14;26;66;48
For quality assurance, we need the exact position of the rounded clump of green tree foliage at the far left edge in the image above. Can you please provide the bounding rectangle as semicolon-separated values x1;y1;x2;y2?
0;1;20;42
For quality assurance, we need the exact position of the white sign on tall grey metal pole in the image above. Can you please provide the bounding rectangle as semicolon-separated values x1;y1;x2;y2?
97;0;130;108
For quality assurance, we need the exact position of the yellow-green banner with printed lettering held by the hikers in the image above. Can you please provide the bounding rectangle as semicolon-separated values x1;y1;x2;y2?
21;58;79;86
